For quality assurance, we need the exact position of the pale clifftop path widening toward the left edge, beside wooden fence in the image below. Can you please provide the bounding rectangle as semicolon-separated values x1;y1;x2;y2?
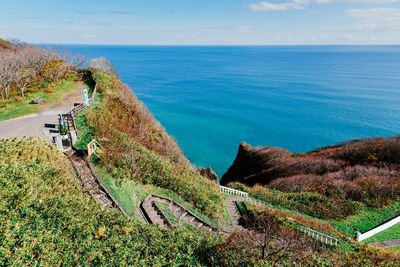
0;82;85;141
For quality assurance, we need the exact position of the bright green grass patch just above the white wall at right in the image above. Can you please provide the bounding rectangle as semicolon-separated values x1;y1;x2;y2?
331;202;400;237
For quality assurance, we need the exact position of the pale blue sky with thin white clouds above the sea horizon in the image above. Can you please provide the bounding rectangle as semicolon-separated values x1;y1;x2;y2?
0;0;400;45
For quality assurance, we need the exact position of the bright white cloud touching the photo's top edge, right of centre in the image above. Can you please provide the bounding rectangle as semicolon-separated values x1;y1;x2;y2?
248;0;398;11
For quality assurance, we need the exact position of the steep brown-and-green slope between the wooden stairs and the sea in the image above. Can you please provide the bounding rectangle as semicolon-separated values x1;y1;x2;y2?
77;71;225;220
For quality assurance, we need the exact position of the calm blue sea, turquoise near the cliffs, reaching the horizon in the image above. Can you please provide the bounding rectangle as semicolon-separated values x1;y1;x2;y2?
59;45;400;176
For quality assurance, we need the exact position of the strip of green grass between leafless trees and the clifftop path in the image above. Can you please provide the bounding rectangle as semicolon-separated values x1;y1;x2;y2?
0;76;77;121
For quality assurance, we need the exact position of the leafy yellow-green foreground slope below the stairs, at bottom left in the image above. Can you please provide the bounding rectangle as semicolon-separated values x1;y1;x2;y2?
0;138;228;266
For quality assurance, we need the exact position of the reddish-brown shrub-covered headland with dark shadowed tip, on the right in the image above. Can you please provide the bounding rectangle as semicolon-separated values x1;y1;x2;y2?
221;136;400;218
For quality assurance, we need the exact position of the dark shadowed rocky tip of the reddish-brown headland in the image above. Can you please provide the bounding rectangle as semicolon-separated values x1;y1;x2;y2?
220;142;292;185
